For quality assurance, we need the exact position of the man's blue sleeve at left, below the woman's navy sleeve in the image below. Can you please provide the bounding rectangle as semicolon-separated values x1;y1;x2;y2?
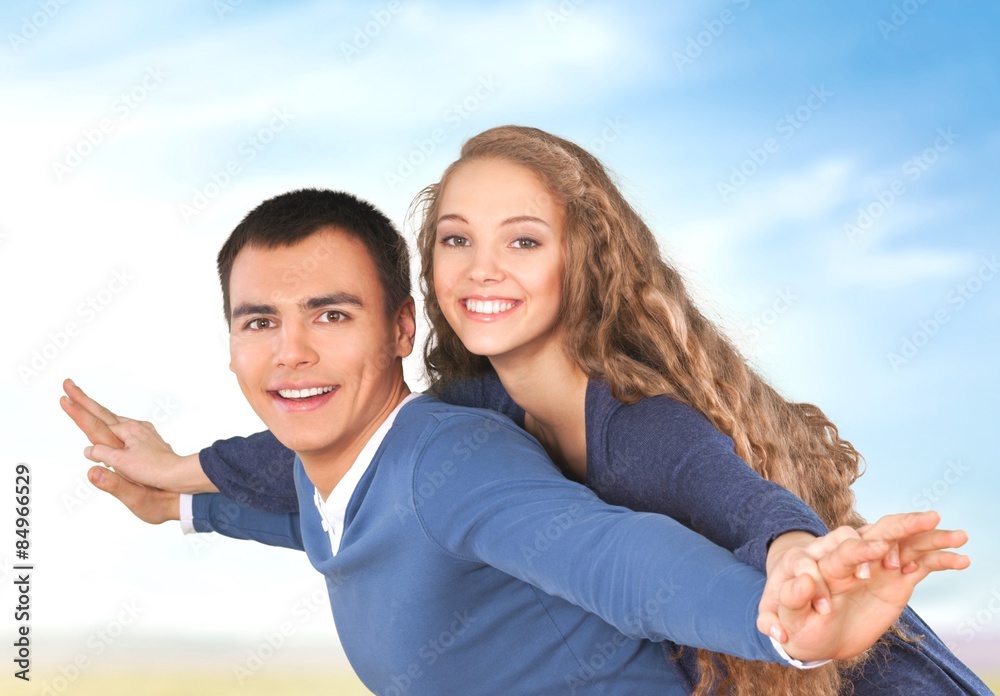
191;493;304;551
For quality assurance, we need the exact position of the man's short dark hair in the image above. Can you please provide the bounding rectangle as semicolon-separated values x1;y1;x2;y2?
218;189;410;324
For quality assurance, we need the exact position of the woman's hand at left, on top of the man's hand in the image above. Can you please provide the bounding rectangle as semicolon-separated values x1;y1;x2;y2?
59;379;218;493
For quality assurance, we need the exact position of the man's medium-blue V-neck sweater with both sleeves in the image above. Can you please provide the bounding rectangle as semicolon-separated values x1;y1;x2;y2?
194;396;780;696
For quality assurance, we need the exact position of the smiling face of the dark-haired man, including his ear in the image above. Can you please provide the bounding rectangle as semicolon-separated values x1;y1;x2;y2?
229;228;414;464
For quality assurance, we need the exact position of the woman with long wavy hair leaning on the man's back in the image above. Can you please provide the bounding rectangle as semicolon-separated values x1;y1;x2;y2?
66;126;989;695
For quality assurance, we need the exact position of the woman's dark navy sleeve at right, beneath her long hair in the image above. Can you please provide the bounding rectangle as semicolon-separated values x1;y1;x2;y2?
590;397;827;570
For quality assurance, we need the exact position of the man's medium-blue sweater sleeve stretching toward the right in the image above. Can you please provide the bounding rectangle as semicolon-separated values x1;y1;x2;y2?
413;415;780;662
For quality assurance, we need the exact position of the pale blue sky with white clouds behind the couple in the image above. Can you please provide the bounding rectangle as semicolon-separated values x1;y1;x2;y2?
0;0;1000;684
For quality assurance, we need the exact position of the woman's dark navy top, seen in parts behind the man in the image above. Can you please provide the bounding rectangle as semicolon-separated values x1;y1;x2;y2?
200;374;991;696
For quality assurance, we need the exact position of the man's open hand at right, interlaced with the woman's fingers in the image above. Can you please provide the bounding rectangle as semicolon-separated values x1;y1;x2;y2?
757;512;969;660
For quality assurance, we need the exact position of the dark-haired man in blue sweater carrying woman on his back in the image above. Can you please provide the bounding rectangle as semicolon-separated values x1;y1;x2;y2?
64;190;960;694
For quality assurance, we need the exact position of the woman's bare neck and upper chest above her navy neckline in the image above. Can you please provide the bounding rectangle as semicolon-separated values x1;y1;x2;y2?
491;344;588;482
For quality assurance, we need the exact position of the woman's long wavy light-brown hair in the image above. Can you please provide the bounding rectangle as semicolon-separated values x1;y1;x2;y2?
413;126;863;696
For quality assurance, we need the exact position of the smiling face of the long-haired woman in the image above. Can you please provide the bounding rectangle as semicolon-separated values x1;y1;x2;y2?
434;159;566;362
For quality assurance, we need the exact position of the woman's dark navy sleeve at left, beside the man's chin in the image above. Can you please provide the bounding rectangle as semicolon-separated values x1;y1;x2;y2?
198;430;299;513
